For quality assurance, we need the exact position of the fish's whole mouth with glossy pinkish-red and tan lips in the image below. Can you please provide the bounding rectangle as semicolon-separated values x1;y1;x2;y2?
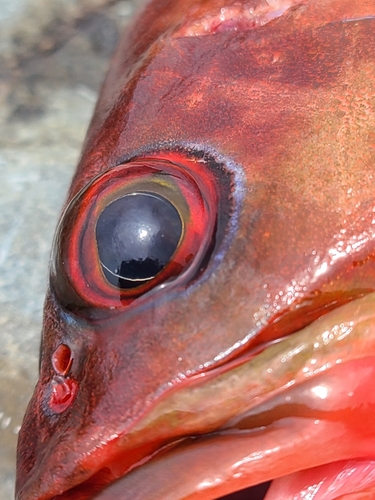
25;293;375;500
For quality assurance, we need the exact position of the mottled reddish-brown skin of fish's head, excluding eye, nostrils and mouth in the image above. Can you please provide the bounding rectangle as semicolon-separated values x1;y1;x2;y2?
17;0;375;500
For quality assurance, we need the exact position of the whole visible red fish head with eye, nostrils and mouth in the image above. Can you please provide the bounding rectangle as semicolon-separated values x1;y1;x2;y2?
16;0;375;500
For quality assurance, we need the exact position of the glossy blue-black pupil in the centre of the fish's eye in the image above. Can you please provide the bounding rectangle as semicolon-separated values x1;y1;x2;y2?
96;193;182;288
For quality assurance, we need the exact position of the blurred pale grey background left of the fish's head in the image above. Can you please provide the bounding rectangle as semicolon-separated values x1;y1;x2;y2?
0;0;144;500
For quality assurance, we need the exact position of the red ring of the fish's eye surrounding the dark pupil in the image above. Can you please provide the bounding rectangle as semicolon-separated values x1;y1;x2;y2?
52;153;218;310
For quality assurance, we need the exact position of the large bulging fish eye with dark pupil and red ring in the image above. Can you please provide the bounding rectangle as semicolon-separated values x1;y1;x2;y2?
50;153;222;317
